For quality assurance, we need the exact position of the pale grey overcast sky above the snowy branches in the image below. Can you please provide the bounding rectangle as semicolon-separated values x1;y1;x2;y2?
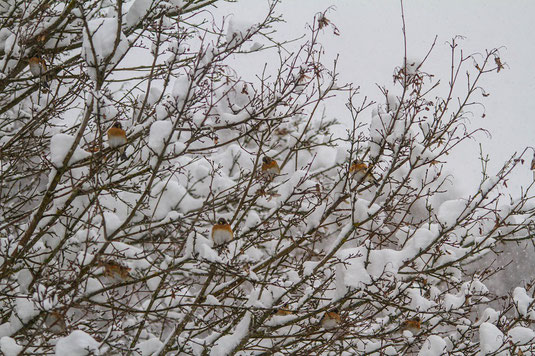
217;0;535;195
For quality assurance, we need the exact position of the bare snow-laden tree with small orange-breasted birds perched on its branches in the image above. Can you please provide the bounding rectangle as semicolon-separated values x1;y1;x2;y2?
0;0;535;355
